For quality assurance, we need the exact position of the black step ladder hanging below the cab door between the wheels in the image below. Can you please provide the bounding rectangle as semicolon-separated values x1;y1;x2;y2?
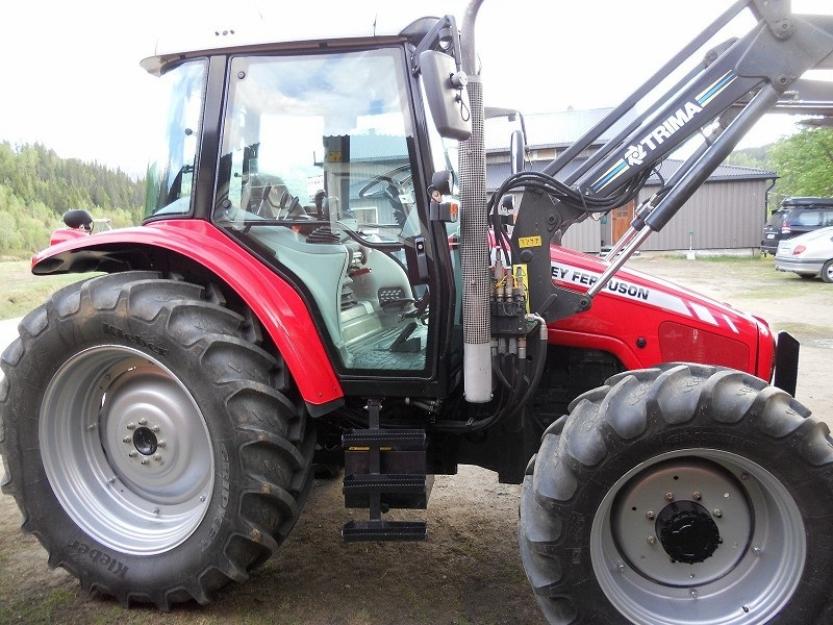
341;399;433;542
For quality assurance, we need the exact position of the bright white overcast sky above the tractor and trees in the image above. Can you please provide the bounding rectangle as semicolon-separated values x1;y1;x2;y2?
0;0;833;175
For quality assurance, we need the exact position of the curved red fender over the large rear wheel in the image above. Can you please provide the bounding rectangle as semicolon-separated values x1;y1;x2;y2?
32;219;344;406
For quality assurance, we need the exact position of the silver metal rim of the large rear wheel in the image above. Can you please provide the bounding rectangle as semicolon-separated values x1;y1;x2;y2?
39;345;214;555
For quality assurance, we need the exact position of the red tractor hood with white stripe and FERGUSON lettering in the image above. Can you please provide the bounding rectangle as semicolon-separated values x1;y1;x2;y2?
550;245;773;379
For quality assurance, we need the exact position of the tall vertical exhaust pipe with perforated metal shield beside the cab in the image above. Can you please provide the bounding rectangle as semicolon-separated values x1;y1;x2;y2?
459;0;492;404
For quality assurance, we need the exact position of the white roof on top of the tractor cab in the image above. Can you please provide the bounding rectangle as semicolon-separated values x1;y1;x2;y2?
141;13;439;75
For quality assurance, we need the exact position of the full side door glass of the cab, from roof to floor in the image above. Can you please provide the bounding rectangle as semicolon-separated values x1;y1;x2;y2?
213;49;429;372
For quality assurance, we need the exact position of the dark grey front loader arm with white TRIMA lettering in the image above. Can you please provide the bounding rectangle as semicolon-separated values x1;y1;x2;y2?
508;0;833;321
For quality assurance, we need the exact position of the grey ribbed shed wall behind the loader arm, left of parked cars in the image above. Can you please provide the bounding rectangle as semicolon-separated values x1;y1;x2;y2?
605;180;770;250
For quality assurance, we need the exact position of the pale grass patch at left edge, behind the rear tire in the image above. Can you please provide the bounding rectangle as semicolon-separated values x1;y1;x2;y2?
0;260;90;319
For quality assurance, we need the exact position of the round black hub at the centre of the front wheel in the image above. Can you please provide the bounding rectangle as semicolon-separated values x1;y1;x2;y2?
656;501;722;564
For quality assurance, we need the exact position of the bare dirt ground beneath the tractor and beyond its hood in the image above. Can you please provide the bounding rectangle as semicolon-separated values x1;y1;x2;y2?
0;252;833;625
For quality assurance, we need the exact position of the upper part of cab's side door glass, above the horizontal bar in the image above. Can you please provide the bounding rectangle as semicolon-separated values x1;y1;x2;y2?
214;49;420;241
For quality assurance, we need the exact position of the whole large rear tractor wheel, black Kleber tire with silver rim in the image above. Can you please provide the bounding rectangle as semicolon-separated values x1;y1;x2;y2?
0;272;315;610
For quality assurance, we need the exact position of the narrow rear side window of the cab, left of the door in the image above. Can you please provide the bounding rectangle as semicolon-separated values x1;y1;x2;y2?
145;60;207;219
